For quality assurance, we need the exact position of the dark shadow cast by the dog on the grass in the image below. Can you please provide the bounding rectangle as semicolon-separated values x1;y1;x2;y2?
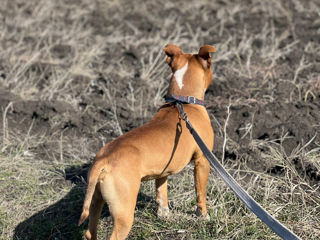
13;164;153;240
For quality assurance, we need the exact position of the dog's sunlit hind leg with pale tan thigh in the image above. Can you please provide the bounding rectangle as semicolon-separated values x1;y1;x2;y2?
100;170;141;240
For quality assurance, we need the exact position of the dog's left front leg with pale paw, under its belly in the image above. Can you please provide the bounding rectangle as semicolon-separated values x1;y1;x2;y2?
156;177;169;217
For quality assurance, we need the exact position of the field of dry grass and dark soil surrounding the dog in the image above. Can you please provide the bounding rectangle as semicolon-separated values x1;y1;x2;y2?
0;0;320;240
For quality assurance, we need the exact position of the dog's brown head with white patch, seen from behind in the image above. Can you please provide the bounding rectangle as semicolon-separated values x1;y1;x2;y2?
163;44;216;99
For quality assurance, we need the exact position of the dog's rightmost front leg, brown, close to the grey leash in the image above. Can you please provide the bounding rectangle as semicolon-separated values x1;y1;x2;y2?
194;155;210;219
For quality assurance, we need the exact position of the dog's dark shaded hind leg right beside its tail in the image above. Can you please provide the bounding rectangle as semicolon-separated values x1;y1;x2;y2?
85;187;104;240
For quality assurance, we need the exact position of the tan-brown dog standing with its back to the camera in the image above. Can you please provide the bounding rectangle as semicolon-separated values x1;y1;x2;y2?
79;44;215;240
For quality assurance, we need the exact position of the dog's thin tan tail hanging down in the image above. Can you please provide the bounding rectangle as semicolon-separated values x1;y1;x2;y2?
78;159;106;226
